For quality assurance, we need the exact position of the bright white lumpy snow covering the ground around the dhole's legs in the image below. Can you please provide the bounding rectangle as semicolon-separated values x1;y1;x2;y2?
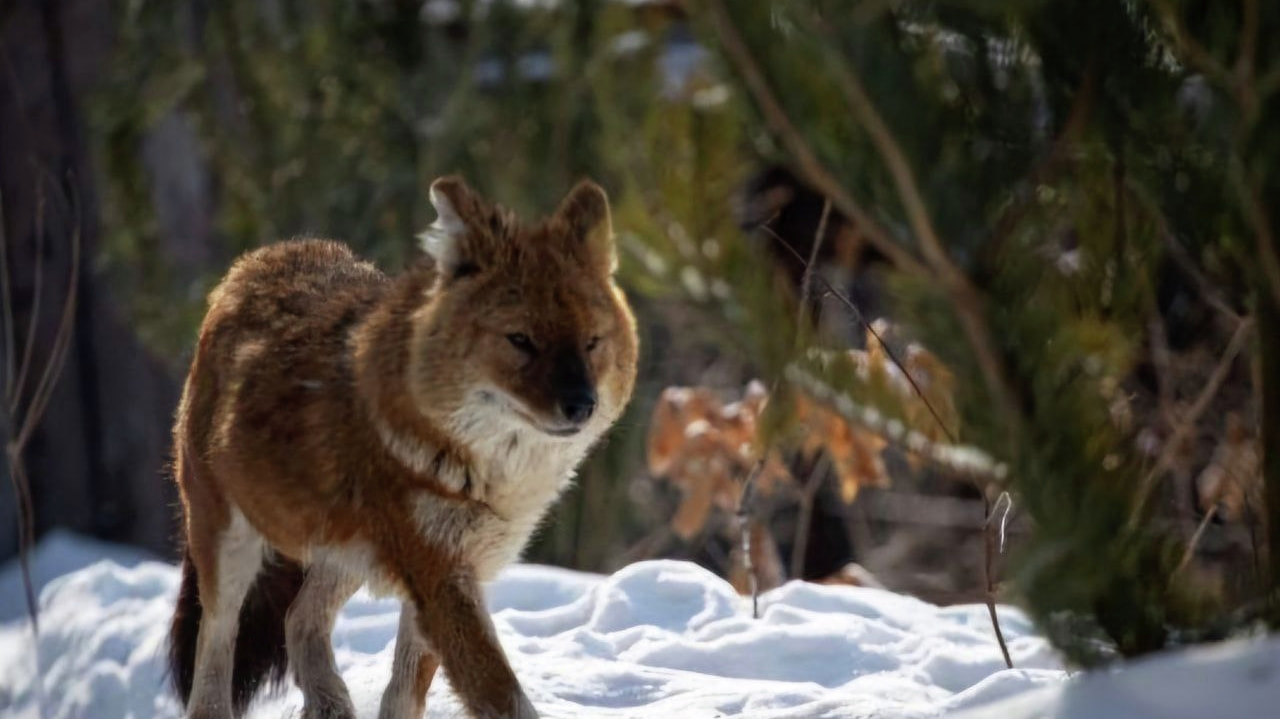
0;536;1280;719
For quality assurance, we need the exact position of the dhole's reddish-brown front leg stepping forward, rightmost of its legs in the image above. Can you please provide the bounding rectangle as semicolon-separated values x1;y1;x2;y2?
406;565;538;719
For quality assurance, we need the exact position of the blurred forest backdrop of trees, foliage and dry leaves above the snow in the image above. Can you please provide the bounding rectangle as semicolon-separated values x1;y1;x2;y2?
0;0;1280;663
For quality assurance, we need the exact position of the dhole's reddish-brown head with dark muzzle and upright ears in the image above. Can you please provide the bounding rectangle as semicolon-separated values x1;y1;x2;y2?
411;177;636;439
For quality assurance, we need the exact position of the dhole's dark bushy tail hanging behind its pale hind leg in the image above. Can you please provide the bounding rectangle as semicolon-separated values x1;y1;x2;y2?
169;550;306;716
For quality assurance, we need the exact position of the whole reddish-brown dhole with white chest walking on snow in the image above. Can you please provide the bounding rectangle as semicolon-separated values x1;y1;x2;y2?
169;178;636;719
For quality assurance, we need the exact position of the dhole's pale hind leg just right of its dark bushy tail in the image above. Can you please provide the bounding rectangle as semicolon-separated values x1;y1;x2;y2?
284;563;361;719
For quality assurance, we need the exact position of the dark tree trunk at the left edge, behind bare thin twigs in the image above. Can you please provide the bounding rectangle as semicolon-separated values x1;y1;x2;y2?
0;0;177;557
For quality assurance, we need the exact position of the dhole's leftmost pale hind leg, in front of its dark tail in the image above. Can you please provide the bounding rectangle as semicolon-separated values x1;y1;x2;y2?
187;509;264;719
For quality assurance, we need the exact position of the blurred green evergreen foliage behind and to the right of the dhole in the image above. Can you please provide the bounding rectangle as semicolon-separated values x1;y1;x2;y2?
93;0;1280;664
